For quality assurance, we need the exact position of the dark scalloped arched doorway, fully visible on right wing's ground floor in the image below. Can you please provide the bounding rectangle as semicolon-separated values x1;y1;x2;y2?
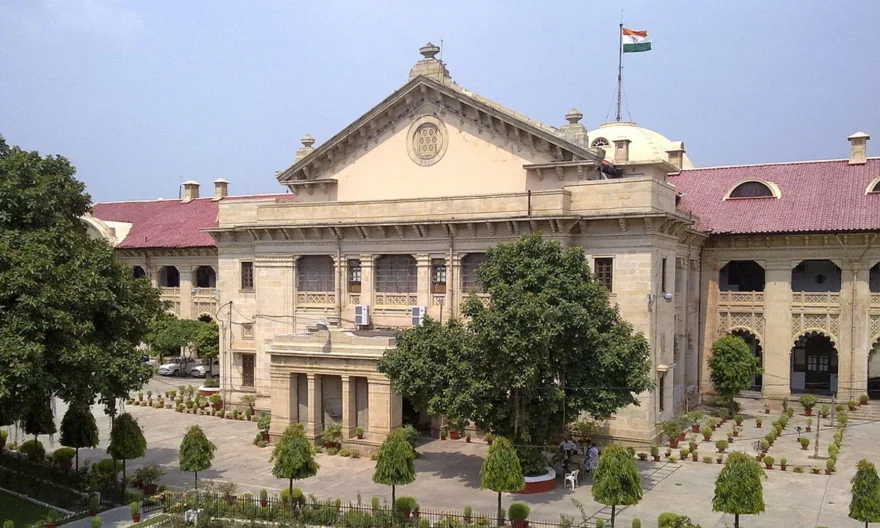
791;332;837;394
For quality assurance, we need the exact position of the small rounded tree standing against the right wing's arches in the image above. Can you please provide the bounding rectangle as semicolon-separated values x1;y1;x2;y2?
709;335;762;416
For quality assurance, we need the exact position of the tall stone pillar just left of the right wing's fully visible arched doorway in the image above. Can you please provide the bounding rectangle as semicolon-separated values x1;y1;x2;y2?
761;260;794;399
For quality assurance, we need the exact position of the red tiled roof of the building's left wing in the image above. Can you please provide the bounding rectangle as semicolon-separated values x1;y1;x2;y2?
92;194;295;249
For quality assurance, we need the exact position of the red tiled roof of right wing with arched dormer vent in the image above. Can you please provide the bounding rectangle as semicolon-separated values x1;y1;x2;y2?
669;158;880;234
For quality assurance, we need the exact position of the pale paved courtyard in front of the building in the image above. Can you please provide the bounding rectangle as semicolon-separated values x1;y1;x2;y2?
5;380;880;528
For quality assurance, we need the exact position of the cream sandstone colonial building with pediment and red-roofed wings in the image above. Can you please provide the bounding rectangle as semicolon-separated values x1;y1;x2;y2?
87;44;880;446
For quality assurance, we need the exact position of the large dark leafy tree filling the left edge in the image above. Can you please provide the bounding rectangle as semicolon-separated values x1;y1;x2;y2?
0;137;162;419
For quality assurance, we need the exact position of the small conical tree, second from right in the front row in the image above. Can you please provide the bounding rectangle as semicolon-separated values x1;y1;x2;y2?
712;451;767;528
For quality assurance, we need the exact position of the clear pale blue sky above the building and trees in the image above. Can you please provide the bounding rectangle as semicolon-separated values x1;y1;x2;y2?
0;0;880;201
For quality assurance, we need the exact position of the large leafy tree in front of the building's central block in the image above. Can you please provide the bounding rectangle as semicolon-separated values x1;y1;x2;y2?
379;235;653;470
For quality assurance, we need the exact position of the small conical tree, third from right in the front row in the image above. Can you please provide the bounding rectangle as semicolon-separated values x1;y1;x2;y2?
592;445;642;528
